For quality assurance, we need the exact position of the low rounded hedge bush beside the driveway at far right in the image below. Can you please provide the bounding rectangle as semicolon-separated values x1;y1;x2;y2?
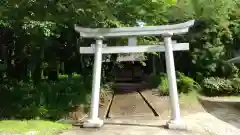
201;77;240;96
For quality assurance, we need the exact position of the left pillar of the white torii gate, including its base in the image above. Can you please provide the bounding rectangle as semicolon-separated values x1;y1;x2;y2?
83;37;103;128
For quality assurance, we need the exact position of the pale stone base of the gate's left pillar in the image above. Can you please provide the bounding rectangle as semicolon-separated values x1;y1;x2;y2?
83;118;103;128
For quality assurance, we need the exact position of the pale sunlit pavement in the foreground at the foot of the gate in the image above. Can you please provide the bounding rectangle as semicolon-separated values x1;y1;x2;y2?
61;112;240;135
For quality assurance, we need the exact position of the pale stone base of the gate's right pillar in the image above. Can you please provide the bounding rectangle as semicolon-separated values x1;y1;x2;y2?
167;120;187;130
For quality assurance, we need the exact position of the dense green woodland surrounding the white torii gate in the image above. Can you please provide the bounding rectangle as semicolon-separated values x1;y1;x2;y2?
0;0;240;119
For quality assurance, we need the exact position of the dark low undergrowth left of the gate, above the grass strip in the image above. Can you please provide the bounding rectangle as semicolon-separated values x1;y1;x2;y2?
0;79;91;119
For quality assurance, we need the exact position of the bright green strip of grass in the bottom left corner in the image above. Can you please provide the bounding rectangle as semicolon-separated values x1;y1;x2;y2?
0;120;72;135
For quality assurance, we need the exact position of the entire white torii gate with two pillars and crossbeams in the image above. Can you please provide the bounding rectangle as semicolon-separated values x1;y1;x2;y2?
75;20;194;129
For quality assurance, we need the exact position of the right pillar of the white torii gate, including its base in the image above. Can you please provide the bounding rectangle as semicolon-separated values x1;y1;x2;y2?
163;32;186;129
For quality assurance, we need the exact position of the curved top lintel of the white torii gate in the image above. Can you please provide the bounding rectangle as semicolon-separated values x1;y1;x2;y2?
75;20;195;38
